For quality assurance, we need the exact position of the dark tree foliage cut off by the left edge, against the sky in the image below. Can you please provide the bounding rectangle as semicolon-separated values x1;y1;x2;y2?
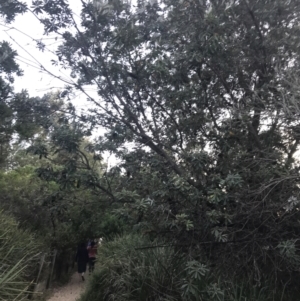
0;1;38;168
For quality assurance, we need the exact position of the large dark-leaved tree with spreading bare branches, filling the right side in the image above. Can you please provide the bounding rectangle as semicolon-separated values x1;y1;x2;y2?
28;0;300;283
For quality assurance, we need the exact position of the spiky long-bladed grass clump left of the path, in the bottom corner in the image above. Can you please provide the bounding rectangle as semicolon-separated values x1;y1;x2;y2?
0;212;41;301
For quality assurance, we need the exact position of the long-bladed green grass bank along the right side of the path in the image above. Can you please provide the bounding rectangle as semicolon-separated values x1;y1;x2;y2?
80;235;300;301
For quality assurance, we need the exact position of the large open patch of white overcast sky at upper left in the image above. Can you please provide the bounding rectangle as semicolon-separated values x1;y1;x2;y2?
0;0;82;101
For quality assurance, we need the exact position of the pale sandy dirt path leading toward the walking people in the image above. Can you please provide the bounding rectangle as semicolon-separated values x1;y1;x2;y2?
48;273;88;301
